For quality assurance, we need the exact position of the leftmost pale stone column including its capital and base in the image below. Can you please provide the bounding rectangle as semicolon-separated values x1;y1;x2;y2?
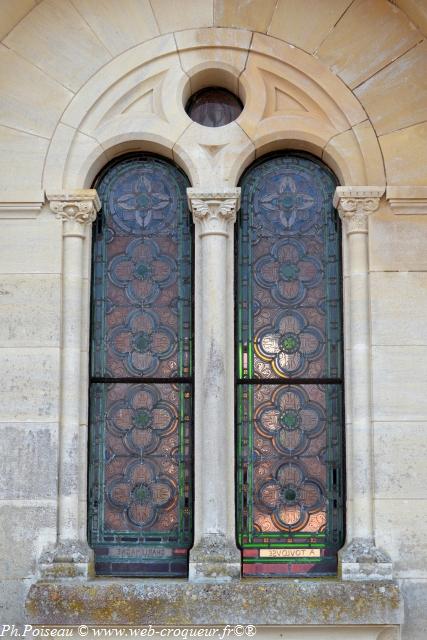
40;189;100;578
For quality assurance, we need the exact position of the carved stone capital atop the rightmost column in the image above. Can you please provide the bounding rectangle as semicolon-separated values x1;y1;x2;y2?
334;187;385;235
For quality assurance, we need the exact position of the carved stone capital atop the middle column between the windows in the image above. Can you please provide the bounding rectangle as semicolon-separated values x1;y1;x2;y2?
187;188;240;236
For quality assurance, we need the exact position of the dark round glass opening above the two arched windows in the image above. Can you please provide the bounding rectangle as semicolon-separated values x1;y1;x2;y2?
186;87;243;127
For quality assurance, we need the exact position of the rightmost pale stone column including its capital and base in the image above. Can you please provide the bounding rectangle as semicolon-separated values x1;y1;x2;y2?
334;187;392;580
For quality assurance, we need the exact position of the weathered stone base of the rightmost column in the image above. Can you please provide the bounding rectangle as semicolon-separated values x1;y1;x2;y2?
339;538;393;581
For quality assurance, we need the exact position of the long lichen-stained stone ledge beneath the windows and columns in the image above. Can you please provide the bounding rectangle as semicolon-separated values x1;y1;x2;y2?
26;579;403;626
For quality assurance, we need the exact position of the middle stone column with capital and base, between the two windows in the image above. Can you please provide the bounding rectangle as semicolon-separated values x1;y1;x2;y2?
187;189;240;582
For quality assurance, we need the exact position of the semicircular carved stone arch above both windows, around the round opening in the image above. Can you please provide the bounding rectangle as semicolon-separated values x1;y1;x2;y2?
43;28;385;192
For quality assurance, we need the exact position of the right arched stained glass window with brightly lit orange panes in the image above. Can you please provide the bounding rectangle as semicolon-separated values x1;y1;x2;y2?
236;153;344;576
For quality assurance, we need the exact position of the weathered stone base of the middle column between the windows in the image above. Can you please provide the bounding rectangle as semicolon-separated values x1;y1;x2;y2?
188;533;241;582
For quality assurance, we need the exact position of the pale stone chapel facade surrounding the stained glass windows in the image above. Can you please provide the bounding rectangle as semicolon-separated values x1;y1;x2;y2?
0;0;427;640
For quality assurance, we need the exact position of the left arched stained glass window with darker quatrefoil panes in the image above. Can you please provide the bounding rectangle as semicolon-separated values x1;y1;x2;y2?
89;155;192;576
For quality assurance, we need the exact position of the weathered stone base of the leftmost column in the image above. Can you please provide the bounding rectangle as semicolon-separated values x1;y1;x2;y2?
39;540;94;580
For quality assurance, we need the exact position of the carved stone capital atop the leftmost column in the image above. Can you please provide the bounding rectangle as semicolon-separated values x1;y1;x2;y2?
47;189;101;225
